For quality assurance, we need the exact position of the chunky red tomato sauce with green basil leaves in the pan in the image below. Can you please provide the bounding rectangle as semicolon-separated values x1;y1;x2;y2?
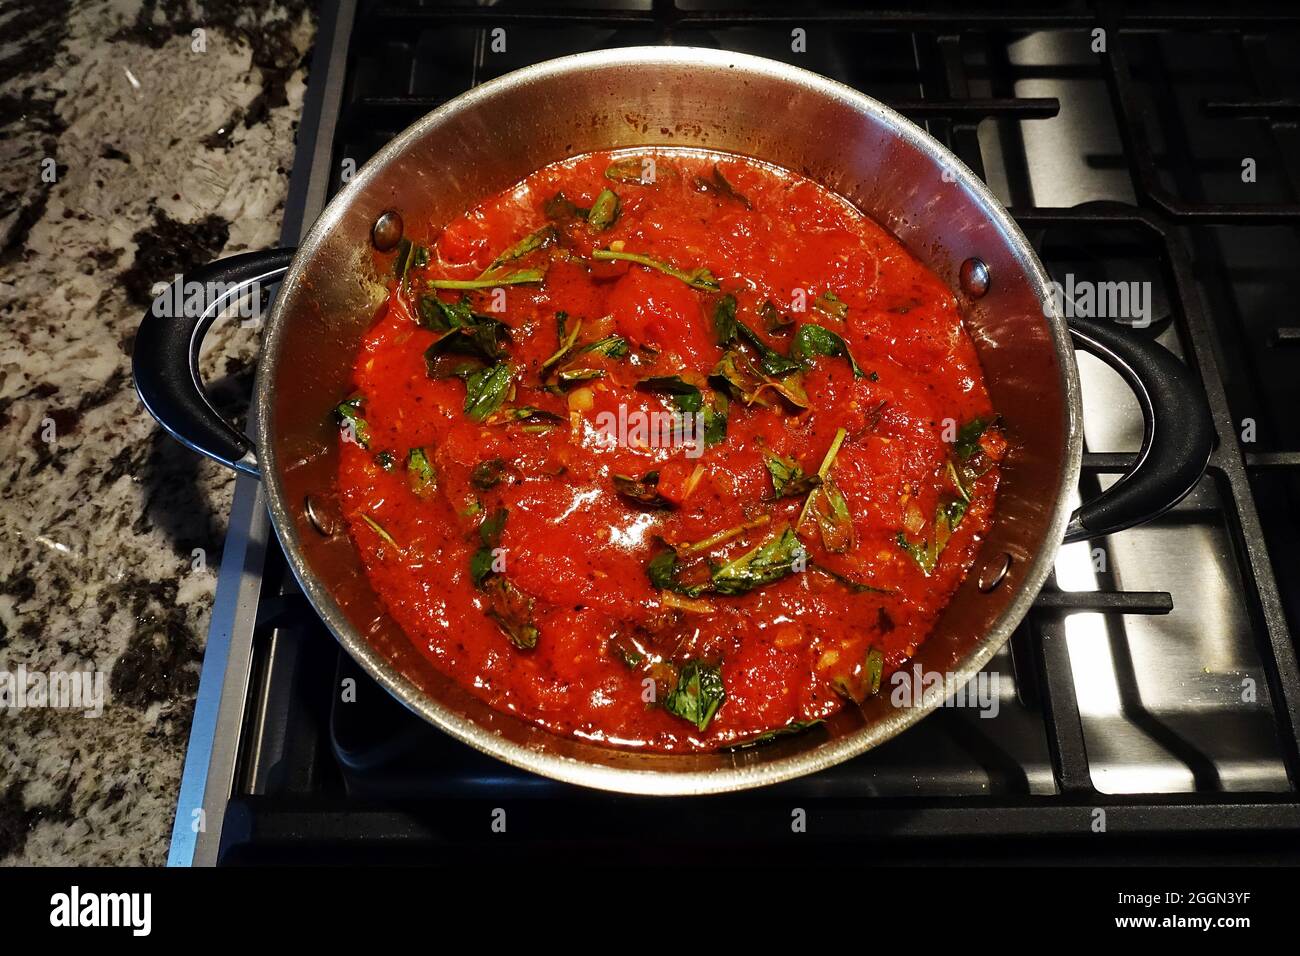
338;150;1005;752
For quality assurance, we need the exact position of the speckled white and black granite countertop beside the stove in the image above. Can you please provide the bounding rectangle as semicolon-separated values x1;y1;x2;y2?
0;0;315;865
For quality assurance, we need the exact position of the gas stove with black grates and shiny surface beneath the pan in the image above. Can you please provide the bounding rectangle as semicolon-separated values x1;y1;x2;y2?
162;0;1300;865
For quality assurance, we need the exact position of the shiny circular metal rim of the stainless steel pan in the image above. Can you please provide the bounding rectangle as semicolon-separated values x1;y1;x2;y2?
254;47;1083;796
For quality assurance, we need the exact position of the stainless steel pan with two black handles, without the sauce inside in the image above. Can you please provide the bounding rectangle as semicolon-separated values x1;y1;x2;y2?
134;48;1214;793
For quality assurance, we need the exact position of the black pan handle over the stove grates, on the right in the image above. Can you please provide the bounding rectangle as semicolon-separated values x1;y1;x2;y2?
1065;319;1214;544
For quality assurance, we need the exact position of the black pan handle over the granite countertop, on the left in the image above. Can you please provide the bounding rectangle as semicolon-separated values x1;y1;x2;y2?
131;248;295;476
